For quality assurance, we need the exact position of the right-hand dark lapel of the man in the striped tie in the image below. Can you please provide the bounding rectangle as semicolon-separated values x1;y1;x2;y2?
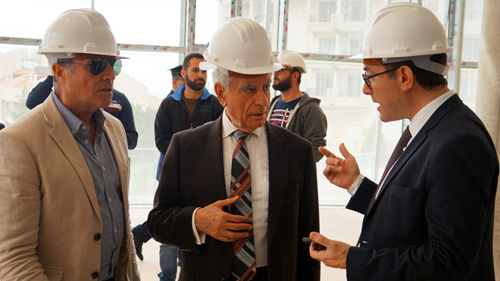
265;122;290;239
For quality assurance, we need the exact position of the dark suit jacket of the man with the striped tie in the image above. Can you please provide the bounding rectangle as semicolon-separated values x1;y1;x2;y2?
148;117;320;281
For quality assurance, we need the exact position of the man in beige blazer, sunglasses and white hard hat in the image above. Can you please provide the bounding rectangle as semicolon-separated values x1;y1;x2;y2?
0;9;139;281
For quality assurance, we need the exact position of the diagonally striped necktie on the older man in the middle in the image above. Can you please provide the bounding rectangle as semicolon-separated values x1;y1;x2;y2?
231;130;257;281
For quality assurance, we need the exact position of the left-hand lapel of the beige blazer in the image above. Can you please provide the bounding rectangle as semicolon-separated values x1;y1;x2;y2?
42;95;101;219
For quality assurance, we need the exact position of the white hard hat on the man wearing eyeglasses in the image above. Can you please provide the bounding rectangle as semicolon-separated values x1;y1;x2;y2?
351;3;453;73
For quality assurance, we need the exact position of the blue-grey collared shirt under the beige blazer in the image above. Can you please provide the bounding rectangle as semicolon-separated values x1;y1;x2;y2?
53;93;125;281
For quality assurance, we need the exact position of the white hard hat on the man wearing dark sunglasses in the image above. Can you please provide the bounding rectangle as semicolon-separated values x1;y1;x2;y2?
38;9;120;64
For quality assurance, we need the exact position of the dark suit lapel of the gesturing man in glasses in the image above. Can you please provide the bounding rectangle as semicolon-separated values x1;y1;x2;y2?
372;94;462;209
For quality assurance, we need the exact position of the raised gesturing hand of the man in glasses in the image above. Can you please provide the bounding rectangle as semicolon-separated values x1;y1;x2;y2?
318;143;360;189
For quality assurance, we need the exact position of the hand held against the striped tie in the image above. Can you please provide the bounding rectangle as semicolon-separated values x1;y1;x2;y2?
194;196;252;242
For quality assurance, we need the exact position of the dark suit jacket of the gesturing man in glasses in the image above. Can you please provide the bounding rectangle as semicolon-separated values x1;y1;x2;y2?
347;95;498;281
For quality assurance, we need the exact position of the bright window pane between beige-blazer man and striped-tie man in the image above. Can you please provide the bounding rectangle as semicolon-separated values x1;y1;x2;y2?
114;51;180;204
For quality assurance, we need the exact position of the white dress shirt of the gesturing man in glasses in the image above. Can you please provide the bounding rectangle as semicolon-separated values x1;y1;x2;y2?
347;90;455;196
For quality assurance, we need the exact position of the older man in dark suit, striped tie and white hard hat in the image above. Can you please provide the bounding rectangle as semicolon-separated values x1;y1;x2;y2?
148;18;320;281
